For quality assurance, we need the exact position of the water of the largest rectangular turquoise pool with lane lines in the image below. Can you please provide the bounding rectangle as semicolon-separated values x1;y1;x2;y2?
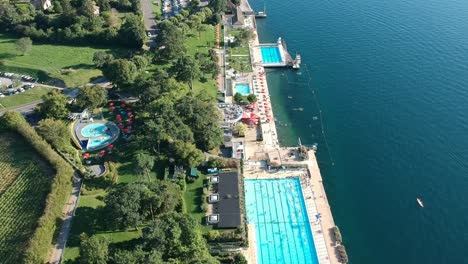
245;178;318;264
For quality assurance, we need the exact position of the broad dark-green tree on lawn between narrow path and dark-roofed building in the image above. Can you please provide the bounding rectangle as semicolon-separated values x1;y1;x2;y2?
104;184;143;229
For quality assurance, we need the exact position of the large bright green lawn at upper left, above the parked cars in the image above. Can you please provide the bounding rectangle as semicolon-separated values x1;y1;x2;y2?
0;34;112;87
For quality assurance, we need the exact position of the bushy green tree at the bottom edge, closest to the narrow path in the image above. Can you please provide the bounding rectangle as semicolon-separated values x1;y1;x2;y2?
79;235;109;264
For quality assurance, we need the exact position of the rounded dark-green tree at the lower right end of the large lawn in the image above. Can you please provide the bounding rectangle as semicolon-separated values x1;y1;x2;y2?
103;59;137;89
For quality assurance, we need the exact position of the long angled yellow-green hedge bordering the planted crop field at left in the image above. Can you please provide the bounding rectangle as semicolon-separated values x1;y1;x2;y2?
0;112;73;263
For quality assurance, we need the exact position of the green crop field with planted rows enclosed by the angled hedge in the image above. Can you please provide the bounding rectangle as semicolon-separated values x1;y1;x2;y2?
0;132;54;263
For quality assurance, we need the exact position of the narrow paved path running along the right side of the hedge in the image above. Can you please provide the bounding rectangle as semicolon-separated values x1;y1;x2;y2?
48;172;82;264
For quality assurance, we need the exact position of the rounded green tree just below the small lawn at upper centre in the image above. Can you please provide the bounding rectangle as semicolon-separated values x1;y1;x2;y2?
171;55;201;90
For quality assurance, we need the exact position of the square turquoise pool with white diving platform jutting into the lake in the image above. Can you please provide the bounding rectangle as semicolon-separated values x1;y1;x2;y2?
258;38;301;69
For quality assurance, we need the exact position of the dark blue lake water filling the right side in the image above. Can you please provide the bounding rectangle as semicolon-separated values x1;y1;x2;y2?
251;0;468;264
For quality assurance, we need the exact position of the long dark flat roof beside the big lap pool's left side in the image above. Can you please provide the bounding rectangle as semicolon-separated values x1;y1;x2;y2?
214;172;241;228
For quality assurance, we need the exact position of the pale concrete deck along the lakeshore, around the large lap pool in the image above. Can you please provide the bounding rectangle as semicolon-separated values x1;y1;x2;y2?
239;5;340;264
